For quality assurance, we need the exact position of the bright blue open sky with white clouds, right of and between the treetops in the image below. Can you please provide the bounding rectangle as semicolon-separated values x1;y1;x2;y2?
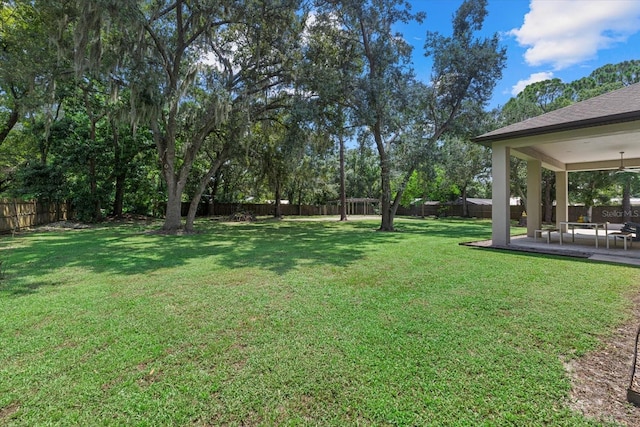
399;0;640;107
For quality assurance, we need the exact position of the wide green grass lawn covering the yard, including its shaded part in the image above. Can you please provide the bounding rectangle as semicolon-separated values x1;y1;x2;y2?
0;219;640;426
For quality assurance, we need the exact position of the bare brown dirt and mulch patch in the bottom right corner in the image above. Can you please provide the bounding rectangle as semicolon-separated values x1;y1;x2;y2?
566;294;640;426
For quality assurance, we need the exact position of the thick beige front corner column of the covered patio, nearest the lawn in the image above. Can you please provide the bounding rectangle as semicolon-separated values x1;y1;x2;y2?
491;144;511;246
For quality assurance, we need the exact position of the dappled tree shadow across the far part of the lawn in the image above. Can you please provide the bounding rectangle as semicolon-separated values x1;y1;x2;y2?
0;222;410;295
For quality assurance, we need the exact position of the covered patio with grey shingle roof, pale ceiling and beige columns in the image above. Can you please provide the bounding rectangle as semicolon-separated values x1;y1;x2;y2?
474;83;640;257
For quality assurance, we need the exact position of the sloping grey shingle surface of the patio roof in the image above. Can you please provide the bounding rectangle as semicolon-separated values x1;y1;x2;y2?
474;83;640;143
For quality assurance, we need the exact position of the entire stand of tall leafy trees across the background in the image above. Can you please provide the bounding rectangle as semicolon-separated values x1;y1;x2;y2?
0;0;640;233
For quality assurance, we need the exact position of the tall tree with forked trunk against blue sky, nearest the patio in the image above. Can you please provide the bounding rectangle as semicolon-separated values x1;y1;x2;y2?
319;0;506;231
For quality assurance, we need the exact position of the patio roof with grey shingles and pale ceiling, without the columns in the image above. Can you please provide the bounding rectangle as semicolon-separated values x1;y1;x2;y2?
474;83;640;171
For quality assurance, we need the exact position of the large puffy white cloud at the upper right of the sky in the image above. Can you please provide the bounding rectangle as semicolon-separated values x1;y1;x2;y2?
509;0;640;70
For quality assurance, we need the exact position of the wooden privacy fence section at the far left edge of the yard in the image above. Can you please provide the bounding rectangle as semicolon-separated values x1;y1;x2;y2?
0;199;67;233
